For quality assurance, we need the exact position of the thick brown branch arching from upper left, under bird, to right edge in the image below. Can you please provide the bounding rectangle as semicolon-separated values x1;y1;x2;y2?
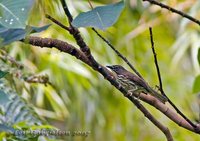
22;36;200;134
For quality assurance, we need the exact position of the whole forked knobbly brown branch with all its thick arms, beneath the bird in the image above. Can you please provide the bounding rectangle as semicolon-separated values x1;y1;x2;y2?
22;0;200;141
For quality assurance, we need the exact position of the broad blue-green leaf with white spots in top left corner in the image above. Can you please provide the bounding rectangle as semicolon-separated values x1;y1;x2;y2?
0;0;34;29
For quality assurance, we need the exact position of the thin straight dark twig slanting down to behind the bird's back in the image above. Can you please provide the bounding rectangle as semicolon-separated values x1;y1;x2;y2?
92;28;143;79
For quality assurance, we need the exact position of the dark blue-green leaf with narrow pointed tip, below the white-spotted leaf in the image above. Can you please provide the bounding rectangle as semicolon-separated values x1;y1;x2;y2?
0;25;50;47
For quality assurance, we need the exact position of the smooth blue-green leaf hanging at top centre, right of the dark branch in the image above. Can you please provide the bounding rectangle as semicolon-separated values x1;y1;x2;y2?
72;1;124;30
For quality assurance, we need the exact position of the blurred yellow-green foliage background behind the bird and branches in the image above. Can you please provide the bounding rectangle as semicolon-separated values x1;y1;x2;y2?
1;0;200;141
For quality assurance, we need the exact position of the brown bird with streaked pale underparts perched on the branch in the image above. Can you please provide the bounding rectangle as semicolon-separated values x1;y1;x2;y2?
106;65;168;103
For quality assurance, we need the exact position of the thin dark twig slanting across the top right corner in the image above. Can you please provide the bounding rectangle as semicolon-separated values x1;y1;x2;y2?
143;0;200;25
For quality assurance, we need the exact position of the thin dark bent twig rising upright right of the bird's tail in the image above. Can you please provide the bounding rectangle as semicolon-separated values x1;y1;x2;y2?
149;27;197;128
